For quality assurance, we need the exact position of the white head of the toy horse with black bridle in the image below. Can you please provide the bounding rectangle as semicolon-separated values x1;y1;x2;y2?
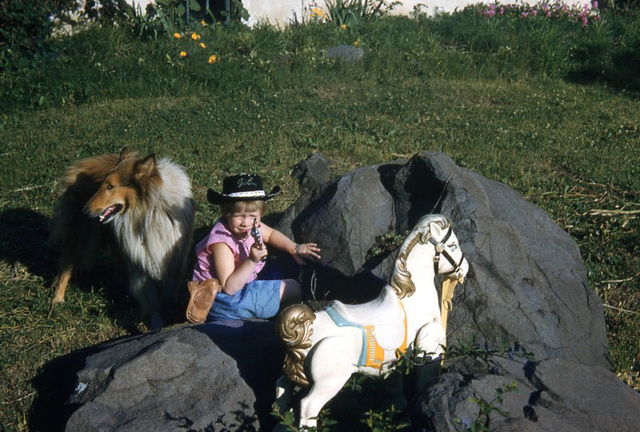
429;216;469;283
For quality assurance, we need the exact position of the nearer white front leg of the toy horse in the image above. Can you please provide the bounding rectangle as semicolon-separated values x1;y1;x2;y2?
416;319;446;392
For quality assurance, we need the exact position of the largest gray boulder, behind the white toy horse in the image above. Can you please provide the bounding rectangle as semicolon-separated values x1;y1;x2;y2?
278;152;609;367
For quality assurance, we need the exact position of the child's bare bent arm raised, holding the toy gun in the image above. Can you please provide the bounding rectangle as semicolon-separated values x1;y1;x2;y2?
209;243;267;295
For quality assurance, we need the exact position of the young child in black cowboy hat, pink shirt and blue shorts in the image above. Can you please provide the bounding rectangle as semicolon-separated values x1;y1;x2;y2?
192;174;320;319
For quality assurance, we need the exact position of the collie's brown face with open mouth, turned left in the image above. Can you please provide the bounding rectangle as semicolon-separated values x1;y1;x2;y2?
84;152;158;223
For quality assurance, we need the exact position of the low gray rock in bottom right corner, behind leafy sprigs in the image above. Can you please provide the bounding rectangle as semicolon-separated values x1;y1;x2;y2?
413;358;640;432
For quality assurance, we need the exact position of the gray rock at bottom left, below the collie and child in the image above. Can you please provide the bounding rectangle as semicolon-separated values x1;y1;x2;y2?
65;321;283;432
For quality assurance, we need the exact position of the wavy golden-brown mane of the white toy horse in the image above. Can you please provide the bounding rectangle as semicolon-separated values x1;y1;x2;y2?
390;215;451;300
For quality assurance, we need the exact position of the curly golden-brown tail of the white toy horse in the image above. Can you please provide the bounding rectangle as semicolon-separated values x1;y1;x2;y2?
276;304;316;387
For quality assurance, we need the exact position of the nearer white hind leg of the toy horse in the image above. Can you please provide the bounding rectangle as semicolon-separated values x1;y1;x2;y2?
300;336;362;428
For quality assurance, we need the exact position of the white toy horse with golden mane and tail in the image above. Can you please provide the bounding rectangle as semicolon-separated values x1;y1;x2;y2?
276;215;469;428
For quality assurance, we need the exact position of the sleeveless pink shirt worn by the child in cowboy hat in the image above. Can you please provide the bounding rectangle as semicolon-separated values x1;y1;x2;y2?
191;219;264;283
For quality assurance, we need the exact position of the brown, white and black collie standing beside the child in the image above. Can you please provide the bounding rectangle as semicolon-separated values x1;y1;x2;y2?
50;148;194;328
